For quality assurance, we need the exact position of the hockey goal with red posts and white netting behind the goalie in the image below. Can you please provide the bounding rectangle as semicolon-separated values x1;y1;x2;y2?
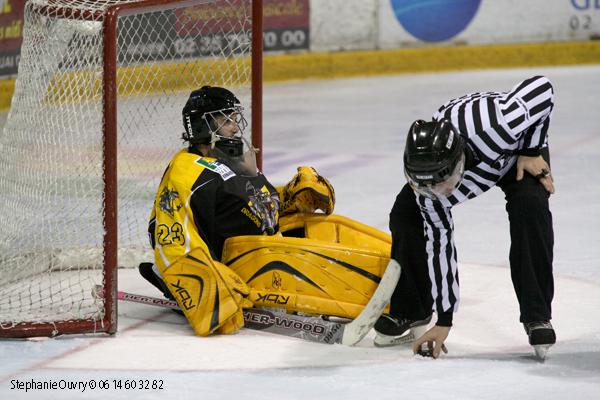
0;0;262;337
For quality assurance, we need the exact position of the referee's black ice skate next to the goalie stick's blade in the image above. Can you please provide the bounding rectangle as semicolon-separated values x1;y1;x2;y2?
373;314;431;347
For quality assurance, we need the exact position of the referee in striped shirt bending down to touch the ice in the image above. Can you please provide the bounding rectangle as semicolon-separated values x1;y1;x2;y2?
375;76;556;358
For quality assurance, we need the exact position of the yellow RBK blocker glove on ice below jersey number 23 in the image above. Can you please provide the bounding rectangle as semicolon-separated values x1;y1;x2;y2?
162;248;252;336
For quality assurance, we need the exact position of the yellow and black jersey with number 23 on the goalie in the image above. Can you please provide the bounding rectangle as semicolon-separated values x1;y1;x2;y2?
148;149;279;273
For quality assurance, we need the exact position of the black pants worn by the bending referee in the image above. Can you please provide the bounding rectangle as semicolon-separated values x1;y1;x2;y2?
390;153;554;322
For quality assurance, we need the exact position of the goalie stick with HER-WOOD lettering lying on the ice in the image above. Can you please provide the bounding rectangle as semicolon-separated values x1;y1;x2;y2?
94;260;401;346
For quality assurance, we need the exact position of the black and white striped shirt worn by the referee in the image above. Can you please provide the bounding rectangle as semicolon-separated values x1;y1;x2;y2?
417;76;554;315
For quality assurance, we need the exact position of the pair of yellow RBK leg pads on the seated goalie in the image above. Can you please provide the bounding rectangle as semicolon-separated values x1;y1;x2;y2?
223;214;391;318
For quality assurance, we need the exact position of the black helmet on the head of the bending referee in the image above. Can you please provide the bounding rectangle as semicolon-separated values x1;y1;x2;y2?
404;118;465;187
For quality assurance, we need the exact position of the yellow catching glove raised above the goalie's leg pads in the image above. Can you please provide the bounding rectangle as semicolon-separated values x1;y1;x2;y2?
277;166;335;215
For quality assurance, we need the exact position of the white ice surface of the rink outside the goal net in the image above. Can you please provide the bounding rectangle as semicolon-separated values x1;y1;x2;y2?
0;66;600;400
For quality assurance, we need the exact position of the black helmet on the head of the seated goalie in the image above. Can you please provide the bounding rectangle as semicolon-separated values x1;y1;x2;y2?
182;86;245;144
